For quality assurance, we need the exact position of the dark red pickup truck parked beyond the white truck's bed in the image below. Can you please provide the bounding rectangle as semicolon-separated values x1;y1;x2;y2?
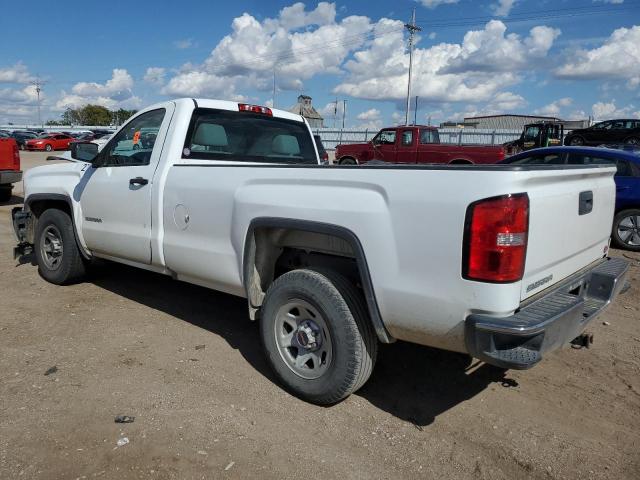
335;125;505;165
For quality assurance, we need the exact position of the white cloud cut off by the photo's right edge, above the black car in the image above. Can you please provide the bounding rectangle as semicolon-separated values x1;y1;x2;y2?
555;25;640;88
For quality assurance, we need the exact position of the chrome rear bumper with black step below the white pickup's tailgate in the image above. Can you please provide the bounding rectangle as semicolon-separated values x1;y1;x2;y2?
465;258;629;370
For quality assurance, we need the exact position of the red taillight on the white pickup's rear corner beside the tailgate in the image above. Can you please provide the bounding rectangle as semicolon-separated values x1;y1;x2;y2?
462;193;529;283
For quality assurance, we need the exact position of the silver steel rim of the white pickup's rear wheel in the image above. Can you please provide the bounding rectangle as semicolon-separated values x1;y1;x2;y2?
273;299;333;380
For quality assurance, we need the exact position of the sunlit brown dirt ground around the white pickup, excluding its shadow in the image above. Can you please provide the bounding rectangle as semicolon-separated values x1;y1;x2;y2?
0;153;640;480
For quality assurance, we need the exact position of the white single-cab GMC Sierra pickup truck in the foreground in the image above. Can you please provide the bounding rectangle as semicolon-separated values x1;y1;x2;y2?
13;99;627;404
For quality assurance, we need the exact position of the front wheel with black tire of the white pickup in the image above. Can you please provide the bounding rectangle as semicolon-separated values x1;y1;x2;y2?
34;208;86;285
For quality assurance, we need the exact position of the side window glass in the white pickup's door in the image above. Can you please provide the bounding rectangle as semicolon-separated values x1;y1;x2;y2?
98;108;165;167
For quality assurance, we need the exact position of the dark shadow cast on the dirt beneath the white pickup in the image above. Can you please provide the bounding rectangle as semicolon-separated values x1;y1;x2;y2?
85;262;517;429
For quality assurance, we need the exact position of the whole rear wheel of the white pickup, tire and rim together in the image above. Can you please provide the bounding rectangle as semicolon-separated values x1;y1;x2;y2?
260;269;378;405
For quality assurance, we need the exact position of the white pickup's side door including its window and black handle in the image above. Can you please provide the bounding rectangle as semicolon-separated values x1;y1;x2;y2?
74;105;174;264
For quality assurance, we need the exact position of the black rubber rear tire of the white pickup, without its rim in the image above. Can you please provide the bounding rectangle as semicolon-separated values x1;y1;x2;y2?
260;269;378;405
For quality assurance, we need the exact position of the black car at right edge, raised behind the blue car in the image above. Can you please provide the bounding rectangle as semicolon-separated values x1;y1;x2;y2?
564;119;640;146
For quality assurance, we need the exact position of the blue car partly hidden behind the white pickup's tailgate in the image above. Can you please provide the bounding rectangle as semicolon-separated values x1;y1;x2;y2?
502;147;640;252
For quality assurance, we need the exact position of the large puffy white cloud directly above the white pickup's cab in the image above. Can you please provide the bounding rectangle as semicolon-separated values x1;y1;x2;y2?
164;2;378;98
